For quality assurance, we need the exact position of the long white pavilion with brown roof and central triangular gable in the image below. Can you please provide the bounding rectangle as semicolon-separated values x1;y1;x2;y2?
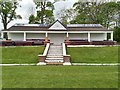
1;20;113;44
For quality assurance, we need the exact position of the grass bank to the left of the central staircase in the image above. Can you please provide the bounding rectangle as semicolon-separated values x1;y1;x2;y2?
2;46;44;63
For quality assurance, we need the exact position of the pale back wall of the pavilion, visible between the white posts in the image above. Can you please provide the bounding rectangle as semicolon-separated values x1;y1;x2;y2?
10;33;107;43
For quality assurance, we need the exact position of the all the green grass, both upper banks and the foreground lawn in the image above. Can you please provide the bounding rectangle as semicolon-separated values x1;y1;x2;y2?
2;46;118;88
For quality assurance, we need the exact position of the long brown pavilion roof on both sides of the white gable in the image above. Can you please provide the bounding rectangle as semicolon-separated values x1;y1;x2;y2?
4;26;111;31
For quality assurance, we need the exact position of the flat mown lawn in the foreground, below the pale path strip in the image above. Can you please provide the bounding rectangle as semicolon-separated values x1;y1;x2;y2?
2;66;118;88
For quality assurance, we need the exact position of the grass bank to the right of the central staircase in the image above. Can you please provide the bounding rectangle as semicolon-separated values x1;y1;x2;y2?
67;47;119;63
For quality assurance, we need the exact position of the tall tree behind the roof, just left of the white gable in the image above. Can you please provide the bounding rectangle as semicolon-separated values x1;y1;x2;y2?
36;0;54;24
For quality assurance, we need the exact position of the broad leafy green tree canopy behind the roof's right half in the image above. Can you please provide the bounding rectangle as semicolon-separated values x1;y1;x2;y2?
71;1;118;28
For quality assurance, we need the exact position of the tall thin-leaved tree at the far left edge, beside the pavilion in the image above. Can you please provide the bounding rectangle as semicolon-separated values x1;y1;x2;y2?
0;0;18;39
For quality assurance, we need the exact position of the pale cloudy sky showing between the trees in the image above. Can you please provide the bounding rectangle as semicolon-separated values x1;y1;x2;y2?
0;0;77;30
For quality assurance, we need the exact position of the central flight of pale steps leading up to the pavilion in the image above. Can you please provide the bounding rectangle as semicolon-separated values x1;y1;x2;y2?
45;44;64;65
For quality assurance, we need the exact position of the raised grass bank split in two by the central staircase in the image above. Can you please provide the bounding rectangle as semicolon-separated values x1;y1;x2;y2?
2;46;118;64
